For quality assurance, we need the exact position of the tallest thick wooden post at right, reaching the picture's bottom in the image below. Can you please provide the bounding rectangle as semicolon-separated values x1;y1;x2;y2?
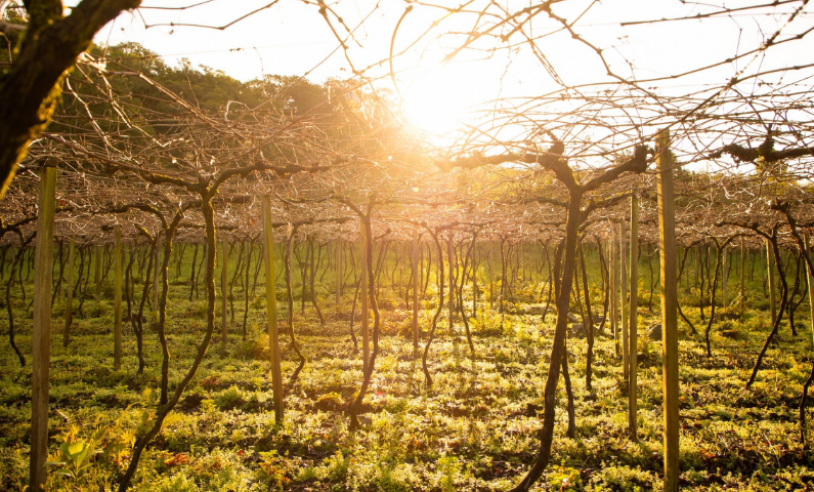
657;130;679;492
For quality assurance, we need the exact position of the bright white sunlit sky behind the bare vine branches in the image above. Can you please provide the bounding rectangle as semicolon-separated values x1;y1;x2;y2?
70;0;814;133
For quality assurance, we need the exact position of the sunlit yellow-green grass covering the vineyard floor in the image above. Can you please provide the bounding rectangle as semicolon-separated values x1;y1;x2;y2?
0;244;814;492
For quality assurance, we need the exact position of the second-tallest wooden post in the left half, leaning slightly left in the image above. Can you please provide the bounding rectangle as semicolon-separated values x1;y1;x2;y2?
263;196;283;425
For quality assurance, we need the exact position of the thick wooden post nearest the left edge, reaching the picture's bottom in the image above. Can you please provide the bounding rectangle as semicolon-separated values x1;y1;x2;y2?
29;158;56;492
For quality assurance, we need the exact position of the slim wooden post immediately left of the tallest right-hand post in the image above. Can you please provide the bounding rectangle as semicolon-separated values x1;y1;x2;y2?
627;195;639;441
